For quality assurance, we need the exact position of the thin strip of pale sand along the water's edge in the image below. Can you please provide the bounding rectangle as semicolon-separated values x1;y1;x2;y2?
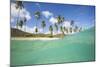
11;37;60;40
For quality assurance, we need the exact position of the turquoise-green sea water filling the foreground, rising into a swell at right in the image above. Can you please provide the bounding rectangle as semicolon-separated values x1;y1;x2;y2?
11;28;95;65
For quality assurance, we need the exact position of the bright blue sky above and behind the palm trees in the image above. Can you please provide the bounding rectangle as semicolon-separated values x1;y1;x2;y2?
11;2;95;32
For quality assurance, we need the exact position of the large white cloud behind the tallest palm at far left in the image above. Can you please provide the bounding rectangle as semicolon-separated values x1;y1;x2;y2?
11;3;31;22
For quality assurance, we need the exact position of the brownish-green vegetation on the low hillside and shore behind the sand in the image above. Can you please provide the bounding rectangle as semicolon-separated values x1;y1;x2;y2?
11;28;62;38
